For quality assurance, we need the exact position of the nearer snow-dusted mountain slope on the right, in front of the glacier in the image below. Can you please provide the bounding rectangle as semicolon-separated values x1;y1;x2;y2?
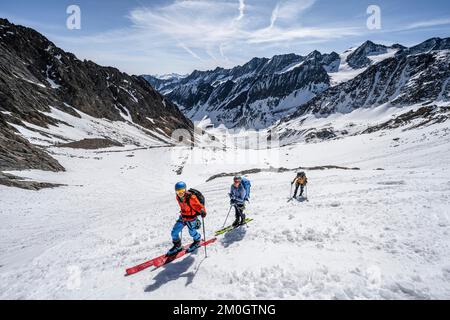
273;39;450;142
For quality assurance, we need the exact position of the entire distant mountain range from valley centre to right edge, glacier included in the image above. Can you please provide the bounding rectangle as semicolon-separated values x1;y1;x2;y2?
144;38;450;129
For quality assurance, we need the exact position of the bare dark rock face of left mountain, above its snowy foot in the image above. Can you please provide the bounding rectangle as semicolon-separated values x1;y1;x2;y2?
0;19;192;135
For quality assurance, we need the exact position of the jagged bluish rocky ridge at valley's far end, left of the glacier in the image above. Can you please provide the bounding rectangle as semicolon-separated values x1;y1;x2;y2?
145;51;339;128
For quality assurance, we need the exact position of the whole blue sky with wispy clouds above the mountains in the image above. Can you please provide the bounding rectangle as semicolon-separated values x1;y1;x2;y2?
0;0;450;75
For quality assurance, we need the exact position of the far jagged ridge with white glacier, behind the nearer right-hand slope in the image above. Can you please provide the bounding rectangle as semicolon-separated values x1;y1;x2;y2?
144;38;449;129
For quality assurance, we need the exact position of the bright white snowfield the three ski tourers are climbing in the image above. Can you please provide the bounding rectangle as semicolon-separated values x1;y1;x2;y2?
0;112;450;299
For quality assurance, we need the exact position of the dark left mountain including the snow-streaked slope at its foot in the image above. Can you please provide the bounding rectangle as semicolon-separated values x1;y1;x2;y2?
0;19;193;178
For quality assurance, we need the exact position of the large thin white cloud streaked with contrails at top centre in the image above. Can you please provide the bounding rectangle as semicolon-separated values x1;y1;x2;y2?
129;0;357;52
